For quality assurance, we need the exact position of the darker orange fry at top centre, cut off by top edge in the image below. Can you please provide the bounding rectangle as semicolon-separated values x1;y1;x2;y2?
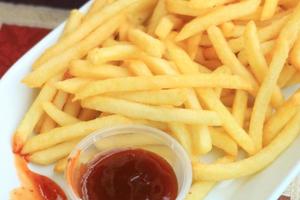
147;0;167;34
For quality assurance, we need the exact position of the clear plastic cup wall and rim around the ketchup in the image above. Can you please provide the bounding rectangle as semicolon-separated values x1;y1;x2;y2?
65;125;192;200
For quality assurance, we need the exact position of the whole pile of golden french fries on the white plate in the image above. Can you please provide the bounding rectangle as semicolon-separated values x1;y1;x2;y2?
13;0;300;200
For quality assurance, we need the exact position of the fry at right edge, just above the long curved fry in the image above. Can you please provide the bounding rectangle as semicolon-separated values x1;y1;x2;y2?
263;90;300;146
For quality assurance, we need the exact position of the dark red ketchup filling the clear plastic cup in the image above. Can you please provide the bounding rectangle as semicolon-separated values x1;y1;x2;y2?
80;149;178;200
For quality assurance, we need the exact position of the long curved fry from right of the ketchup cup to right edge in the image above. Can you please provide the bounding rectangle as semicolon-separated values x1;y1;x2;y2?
193;111;300;181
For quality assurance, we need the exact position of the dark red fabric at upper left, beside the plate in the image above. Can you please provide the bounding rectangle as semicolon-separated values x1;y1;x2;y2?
0;24;50;77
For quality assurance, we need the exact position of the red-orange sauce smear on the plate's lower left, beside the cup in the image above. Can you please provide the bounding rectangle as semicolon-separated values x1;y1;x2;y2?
11;155;67;200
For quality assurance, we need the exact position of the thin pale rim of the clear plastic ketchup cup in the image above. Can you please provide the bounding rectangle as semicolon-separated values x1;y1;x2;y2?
64;125;192;200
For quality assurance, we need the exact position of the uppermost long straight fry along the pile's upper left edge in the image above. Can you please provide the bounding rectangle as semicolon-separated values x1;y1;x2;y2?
34;0;137;66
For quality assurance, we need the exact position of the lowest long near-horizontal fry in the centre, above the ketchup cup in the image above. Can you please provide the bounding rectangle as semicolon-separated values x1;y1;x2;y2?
81;96;222;126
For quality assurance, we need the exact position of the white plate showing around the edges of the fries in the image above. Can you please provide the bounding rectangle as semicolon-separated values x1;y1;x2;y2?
0;0;300;200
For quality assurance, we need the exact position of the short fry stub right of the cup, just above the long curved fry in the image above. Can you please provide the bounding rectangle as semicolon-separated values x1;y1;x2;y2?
209;128;238;156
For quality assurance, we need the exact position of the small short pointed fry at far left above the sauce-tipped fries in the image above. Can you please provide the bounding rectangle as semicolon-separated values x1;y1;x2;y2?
43;102;79;126
